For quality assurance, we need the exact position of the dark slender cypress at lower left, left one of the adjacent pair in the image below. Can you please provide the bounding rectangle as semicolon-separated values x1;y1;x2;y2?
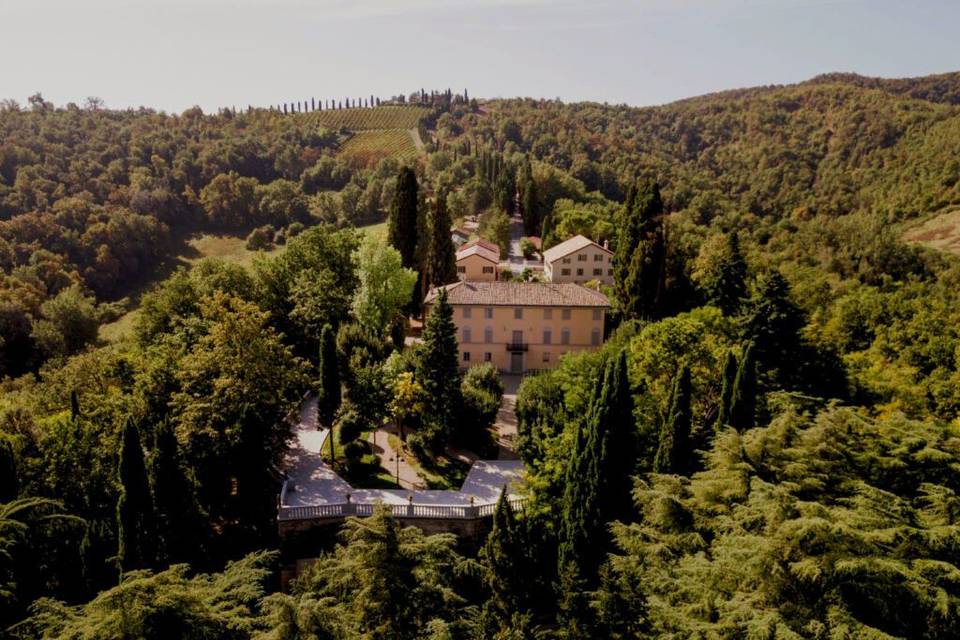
117;416;156;571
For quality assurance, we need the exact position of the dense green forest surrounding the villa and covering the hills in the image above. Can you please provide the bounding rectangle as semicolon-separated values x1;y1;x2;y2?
0;74;960;640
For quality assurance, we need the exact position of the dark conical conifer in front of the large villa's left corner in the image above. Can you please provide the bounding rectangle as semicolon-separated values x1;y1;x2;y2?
416;289;462;451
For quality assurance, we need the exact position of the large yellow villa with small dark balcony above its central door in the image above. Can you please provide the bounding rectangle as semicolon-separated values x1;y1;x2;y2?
424;281;610;373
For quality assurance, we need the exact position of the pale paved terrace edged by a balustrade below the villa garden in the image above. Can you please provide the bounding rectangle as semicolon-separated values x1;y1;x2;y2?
278;397;523;520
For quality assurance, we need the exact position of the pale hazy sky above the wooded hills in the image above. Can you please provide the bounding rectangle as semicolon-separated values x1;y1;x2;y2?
0;0;960;112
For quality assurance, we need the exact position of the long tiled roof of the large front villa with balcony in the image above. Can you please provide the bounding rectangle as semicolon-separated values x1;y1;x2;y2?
424;282;610;307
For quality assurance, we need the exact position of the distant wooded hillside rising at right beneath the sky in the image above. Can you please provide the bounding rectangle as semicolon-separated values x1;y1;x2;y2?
440;74;960;221
